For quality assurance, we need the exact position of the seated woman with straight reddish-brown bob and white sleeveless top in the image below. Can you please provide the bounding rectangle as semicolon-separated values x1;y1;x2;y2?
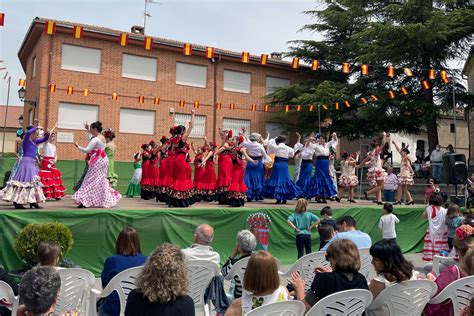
225;250;289;316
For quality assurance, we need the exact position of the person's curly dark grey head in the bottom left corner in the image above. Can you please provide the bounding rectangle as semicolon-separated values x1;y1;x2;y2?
17;266;61;316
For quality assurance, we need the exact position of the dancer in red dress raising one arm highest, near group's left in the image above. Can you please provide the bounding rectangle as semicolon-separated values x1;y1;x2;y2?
167;110;195;207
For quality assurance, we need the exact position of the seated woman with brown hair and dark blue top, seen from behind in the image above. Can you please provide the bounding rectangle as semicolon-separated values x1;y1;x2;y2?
97;227;146;316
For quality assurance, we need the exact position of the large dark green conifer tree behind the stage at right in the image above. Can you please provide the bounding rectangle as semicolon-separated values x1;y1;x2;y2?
271;0;474;150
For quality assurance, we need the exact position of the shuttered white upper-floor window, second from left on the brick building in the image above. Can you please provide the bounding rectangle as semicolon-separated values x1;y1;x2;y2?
122;54;156;81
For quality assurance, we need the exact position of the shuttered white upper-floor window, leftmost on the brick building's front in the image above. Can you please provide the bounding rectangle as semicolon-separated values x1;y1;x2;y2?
61;44;101;74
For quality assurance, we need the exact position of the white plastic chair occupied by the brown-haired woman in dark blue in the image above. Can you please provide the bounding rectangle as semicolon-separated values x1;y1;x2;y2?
89;266;143;316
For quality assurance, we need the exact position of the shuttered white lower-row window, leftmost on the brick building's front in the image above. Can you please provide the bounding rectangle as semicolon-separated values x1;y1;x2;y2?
58;102;99;130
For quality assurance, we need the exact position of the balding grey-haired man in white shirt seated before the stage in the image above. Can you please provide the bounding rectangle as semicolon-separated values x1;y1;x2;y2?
181;224;221;265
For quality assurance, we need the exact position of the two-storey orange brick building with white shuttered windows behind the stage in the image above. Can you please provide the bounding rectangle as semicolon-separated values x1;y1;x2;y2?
18;18;306;160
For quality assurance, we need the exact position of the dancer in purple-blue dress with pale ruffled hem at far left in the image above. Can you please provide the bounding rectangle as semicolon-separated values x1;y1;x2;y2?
1;125;56;209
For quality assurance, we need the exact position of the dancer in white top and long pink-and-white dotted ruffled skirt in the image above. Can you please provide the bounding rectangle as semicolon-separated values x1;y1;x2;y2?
72;121;122;208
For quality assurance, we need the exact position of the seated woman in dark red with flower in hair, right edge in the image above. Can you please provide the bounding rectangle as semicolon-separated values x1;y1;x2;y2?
424;225;474;316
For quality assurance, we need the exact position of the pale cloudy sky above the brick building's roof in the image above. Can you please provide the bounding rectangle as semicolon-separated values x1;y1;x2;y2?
0;0;322;105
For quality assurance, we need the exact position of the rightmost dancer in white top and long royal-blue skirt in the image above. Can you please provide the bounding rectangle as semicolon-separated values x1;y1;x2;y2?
309;133;340;203
